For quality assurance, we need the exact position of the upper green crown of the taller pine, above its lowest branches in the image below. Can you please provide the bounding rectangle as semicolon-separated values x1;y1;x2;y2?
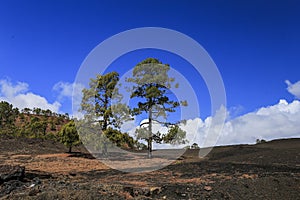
127;58;180;117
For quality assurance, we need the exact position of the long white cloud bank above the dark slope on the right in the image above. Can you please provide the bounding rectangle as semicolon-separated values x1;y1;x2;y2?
123;100;300;148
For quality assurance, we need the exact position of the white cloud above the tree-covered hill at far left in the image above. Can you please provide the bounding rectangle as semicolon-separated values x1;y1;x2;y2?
0;79;61;112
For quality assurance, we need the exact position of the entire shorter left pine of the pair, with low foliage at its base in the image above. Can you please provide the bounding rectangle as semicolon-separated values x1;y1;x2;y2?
79;72;135;155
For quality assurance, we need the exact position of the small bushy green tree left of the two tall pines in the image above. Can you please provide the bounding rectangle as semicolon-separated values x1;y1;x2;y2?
58;120;81;153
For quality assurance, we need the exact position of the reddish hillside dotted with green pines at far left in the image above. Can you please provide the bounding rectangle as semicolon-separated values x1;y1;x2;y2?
0;101;70;143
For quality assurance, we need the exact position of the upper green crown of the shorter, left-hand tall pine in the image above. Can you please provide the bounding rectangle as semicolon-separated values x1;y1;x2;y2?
81;72;129;130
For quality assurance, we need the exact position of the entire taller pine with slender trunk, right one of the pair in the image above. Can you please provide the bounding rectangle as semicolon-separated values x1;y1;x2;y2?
127;58;187;157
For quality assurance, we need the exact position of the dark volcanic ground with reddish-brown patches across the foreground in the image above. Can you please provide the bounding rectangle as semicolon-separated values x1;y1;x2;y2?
0;136;300;199
